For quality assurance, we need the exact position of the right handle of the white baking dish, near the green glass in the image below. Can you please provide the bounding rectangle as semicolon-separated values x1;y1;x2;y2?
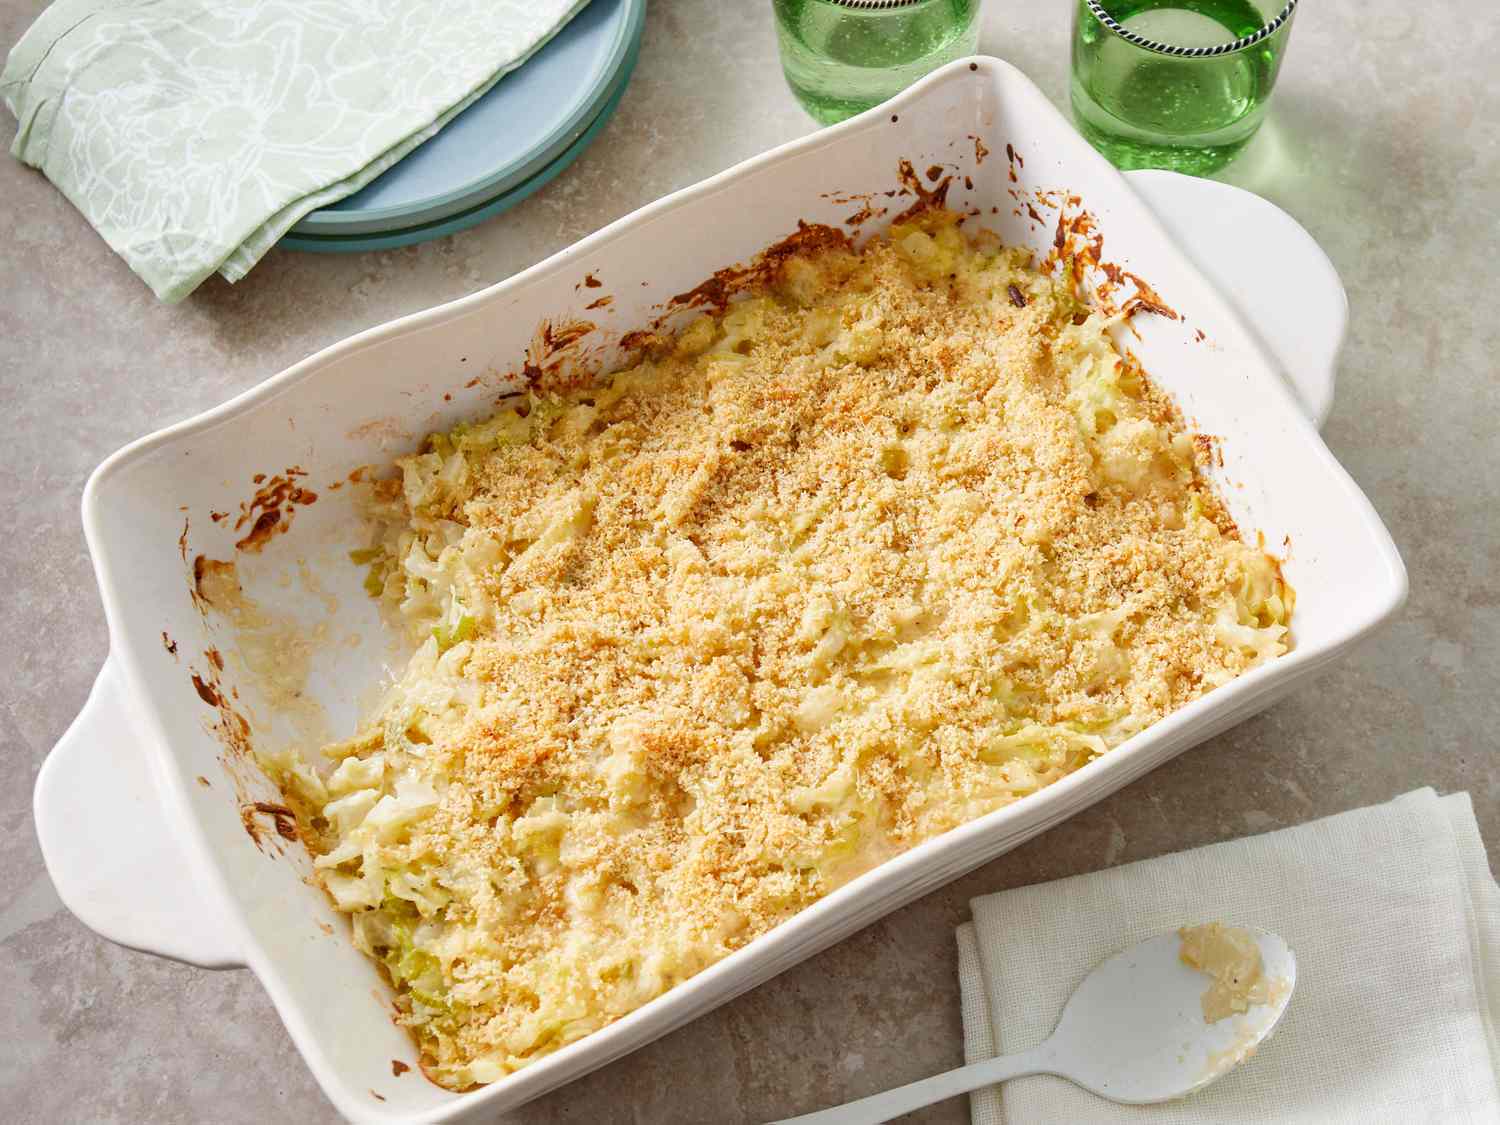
1125;170;1349;426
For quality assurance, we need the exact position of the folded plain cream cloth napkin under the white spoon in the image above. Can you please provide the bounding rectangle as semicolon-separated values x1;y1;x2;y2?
959;789;1500;1125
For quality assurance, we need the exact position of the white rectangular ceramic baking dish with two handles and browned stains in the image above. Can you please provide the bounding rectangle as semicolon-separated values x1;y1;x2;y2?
36;59;1406;1121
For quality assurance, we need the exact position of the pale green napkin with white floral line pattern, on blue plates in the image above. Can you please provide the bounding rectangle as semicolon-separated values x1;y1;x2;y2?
0;0;588;302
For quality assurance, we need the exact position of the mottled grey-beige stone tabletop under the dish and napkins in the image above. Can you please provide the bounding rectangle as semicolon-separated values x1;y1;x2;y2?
0;0;1500;1125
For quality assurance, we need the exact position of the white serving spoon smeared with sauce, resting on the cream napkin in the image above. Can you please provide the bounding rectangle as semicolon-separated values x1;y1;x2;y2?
782;930;1298;1125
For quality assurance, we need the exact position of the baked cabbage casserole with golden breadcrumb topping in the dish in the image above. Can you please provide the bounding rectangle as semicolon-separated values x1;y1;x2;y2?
282;210;1292;1088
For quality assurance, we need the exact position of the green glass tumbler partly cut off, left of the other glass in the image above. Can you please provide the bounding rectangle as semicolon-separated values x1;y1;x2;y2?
774;0;980;125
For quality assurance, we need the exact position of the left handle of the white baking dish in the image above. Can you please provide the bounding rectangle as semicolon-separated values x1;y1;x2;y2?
33;660;245;969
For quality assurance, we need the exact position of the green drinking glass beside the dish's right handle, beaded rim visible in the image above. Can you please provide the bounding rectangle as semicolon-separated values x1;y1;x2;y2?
1073;0;1298;176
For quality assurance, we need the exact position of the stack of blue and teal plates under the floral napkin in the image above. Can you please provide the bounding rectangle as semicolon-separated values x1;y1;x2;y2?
281;0;647;252
